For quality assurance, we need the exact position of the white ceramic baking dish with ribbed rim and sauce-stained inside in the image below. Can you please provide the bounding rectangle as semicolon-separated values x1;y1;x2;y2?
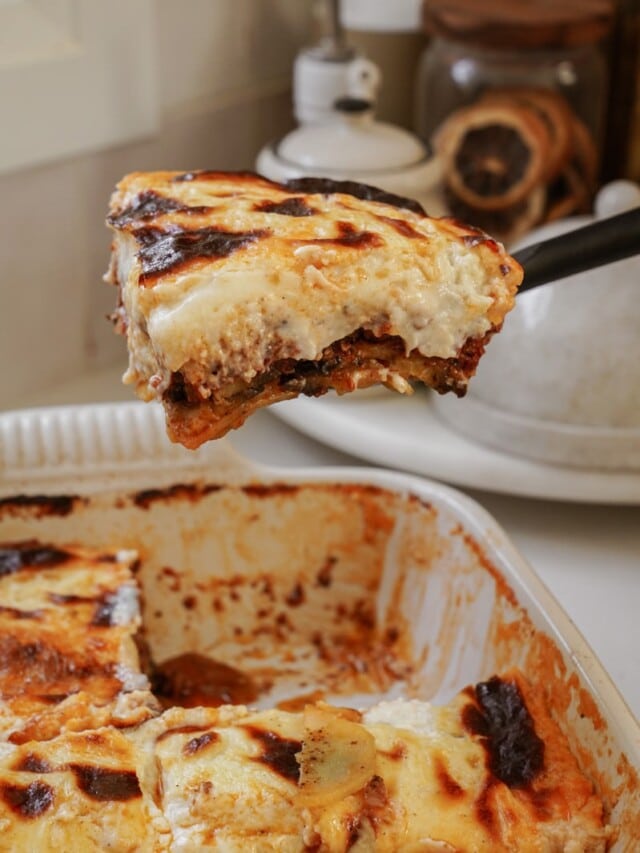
0;403;640;853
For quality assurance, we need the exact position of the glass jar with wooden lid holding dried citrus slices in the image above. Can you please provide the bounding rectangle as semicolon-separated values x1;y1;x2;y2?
416;0;613;246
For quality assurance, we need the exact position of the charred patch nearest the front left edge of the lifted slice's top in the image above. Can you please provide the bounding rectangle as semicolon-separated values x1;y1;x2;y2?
134;226;270;286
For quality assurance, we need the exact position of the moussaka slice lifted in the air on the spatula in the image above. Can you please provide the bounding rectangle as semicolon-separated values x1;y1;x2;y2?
108;172;523;448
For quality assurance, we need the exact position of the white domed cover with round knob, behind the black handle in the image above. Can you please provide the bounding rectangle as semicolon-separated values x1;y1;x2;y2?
434;181;640;473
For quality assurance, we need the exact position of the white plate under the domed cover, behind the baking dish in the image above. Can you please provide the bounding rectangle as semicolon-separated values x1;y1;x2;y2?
271;390;640;505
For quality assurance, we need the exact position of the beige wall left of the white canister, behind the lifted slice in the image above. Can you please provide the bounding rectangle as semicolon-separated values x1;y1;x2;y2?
0;0;312;409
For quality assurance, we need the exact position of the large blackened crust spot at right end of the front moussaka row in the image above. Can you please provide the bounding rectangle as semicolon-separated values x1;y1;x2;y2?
463;677;544;788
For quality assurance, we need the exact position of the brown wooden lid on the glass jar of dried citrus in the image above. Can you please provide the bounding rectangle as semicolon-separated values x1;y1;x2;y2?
422;0;614;50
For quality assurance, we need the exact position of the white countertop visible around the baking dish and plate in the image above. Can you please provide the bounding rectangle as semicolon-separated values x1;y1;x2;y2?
5;369;640;717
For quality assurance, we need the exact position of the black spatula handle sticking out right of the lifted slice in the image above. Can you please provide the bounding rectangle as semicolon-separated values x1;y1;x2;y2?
513;207;640;295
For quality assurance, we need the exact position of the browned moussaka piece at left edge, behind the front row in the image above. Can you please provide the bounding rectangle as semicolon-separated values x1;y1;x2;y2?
0;541;156;744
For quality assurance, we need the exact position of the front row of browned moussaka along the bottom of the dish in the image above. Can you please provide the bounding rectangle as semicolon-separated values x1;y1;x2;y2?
0;672;610;853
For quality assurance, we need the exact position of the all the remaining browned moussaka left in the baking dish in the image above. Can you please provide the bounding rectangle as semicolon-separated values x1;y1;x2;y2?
0;541;610;853
